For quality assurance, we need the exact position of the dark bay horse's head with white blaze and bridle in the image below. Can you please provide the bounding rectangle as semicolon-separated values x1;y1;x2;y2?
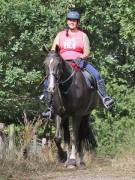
44;51;63;93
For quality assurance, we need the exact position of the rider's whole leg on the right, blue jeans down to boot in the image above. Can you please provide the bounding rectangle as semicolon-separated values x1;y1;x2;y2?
79;60;114;109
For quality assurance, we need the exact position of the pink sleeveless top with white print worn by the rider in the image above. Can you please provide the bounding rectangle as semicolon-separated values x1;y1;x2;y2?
59;30;84;59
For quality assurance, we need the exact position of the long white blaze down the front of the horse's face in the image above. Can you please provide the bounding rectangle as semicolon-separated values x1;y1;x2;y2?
48;58;55;92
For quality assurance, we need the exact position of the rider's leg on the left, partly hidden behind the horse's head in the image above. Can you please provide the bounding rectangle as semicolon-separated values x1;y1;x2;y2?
40;79;54;119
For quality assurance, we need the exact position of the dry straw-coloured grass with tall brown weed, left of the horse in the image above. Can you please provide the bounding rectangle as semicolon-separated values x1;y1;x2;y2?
0;113;56;180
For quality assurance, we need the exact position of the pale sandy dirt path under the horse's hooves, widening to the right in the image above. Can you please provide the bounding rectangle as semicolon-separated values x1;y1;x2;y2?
29;159;135;180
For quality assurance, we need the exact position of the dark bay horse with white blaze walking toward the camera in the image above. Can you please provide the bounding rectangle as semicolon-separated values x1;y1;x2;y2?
44;51;99;166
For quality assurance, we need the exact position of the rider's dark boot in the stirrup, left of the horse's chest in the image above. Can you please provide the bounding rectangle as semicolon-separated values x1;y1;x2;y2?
40;92;54;119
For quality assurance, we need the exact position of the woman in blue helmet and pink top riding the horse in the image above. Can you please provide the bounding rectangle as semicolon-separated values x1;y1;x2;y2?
43;10;114;117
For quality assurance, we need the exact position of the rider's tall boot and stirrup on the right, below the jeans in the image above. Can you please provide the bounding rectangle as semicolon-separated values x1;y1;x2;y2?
97;79;114;109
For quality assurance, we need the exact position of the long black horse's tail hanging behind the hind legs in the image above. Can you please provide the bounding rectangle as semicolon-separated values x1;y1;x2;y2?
78;115;97;151
